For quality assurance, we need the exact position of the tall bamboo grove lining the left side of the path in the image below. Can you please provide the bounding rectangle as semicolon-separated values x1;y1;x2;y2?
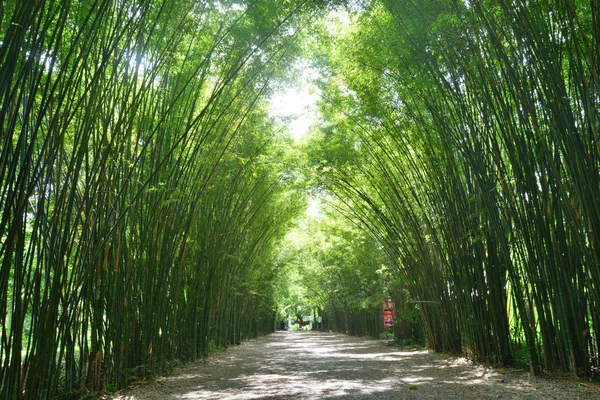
0;0;324;399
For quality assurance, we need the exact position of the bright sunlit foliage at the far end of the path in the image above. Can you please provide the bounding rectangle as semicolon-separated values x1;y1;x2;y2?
276;209;394;338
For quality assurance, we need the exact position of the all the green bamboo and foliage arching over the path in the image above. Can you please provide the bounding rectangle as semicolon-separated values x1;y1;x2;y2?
0;0;600;399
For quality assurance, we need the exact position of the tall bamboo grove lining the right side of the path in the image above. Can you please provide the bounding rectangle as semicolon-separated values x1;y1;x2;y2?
312;0;600;376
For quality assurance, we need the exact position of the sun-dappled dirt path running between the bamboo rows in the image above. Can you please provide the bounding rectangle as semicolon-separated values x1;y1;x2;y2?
117;332;600;400
